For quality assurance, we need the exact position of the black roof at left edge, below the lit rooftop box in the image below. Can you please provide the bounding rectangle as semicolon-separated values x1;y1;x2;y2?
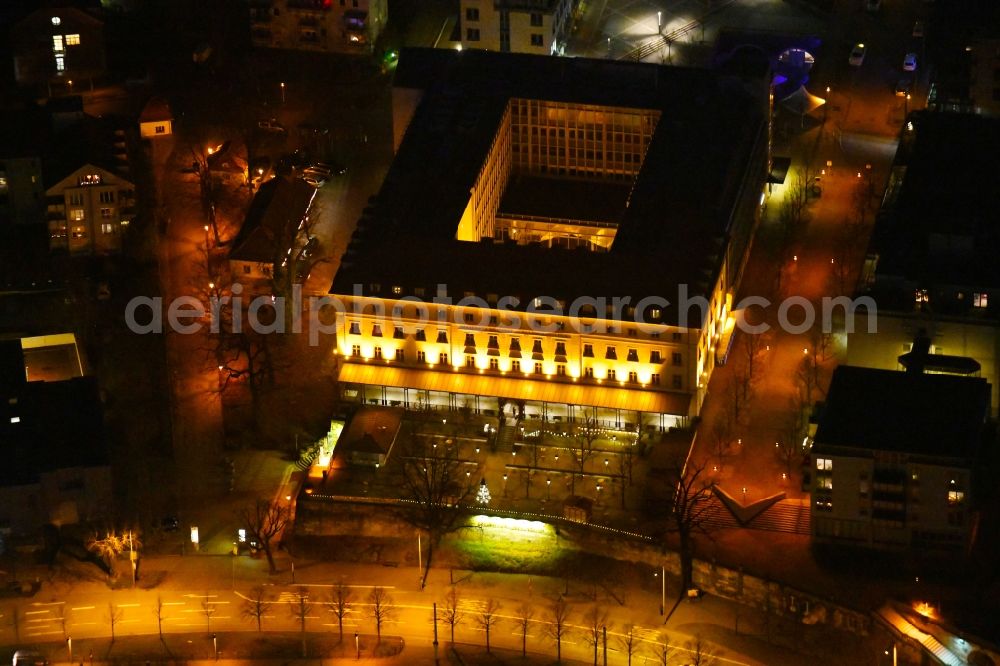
0;377;108;486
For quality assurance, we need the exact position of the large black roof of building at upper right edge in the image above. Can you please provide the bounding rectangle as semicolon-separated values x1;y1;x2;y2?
872;112;1000;309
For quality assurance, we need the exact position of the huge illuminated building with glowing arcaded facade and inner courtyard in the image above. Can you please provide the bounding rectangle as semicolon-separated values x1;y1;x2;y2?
331;49;769;428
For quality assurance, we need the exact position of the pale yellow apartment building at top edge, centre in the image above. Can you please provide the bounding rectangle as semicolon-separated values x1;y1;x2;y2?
459;0;577;55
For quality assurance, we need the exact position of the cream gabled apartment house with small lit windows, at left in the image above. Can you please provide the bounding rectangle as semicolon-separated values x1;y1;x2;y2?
45;164;135;255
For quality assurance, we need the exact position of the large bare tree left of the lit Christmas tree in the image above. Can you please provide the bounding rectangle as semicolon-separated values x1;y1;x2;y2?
399;435;473;585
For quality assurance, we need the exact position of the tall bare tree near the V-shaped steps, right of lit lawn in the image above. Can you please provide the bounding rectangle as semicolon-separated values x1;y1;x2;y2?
667;457;715;590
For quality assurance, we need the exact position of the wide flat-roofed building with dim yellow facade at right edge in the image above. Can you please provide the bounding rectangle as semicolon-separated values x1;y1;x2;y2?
847;112;1000;414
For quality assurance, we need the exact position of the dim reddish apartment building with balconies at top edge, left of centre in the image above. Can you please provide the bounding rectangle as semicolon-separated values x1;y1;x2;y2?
249;0;389;53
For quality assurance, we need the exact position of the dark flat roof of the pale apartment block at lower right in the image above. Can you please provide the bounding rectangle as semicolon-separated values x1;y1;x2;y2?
814;365;990;458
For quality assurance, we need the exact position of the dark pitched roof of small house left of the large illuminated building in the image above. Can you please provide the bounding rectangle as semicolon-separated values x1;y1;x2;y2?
229;177;316;263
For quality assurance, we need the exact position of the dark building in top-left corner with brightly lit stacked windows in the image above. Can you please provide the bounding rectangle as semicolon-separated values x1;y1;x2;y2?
10;7;107;89
